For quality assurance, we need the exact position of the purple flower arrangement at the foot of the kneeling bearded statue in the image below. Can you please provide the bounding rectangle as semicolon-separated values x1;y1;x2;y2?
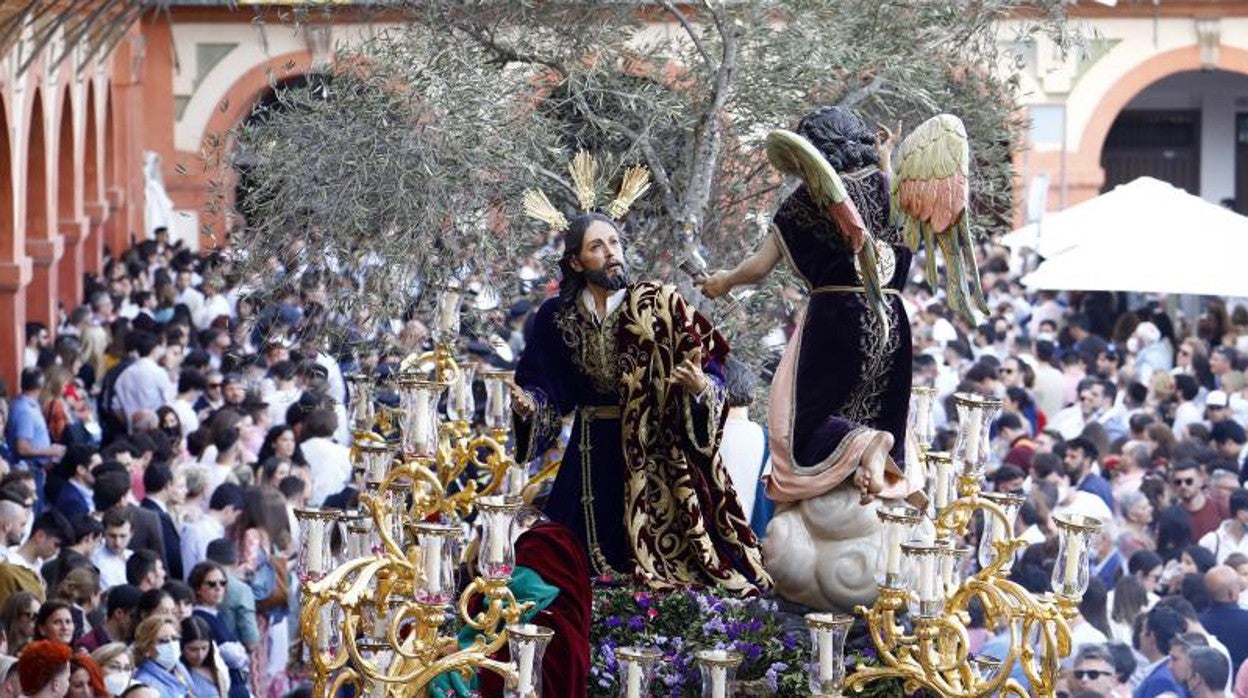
589;588;904;698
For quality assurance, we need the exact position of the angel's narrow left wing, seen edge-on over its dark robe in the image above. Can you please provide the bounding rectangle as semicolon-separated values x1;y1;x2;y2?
766;129;890;335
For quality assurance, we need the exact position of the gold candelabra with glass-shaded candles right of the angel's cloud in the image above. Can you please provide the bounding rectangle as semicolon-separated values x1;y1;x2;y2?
843;388;1099;698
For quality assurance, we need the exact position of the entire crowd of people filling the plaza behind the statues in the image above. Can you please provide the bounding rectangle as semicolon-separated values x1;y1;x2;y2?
0;218;1248;698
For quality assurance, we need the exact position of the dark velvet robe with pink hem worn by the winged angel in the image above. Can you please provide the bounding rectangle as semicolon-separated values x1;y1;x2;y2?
768;167;911;501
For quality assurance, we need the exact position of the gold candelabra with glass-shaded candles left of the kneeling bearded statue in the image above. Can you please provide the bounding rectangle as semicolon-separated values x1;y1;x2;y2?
296;288;549;698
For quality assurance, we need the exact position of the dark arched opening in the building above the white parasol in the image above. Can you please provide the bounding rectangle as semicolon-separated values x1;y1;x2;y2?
1101;70;1248;214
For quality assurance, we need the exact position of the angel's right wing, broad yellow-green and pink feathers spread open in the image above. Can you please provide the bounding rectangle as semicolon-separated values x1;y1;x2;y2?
892;114;988;325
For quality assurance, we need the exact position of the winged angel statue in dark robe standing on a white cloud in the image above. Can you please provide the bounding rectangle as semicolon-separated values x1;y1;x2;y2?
701;107;987;608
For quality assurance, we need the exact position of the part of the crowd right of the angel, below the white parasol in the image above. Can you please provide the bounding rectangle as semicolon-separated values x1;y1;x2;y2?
907;248;1248;698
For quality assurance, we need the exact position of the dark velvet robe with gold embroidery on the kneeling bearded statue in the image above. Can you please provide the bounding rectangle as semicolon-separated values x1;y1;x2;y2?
515;282;770;593
